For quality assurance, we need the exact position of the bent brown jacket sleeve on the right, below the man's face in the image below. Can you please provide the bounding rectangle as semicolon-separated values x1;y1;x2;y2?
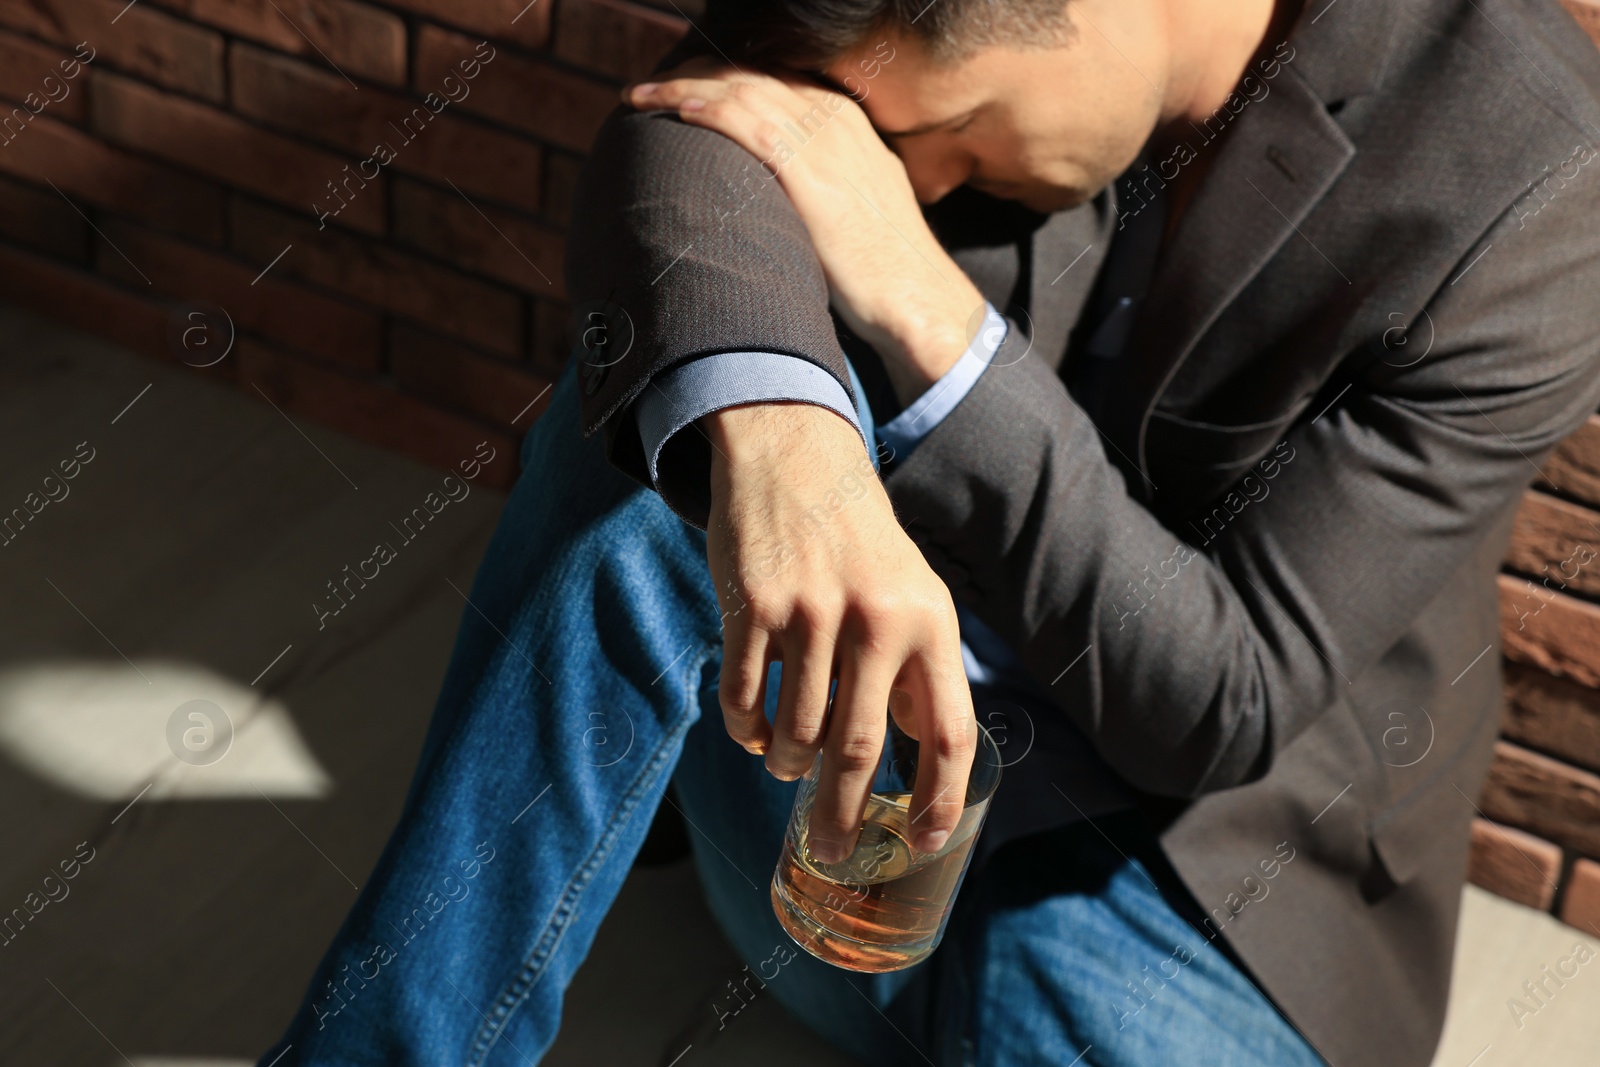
886;181;1600;797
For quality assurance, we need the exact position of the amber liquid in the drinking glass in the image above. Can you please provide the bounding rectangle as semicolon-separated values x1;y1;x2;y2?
771;792;986;971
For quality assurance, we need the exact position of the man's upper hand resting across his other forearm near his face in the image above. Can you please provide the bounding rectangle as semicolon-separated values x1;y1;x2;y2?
622;59;984;405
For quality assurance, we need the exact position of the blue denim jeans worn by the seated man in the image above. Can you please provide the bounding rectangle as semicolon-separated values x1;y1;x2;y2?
261;361;1322;1067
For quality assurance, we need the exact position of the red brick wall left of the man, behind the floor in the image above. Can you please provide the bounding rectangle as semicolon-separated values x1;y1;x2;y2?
0;0;699;483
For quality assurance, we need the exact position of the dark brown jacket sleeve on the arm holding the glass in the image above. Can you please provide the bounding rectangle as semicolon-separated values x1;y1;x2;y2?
565;107;856;526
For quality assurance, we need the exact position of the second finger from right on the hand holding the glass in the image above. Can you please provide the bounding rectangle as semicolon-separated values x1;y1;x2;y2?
806;653;899;864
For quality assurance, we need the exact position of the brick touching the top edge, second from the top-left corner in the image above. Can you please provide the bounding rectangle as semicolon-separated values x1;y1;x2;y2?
150;0;405;88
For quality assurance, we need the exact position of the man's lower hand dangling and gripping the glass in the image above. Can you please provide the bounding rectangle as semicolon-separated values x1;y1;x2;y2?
702;403;978;862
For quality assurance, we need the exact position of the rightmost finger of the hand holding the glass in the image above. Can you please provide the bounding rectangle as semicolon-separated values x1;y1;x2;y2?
899;649;978;853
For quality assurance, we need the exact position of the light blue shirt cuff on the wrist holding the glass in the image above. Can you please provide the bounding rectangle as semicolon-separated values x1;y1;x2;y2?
634;350;870;490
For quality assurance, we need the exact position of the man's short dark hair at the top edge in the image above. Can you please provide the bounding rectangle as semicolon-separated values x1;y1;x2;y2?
704;0;1072;70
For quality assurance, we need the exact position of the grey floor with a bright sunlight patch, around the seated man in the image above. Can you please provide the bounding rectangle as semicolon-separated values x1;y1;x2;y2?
0;306;1600;1067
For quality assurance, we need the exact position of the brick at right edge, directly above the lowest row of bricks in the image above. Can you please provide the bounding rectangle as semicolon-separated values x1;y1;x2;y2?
1480;741;1600;856
